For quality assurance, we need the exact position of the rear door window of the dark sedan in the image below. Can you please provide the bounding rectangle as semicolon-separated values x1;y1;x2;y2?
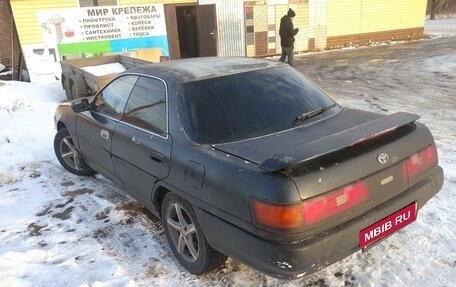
122;77;167;135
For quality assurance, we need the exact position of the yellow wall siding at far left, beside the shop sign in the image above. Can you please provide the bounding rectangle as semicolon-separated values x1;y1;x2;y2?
11;0;77;45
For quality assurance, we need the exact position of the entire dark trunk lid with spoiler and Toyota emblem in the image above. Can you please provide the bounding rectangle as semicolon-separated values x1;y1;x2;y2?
214;109;433;204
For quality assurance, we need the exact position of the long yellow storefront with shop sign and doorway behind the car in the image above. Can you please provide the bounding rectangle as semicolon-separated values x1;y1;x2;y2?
10;0;427;81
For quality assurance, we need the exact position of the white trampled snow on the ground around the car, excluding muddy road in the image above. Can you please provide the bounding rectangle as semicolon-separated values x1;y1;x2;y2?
0;16;456;287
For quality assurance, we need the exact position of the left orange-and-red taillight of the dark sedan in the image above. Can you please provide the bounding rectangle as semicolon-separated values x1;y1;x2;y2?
252;181;370;229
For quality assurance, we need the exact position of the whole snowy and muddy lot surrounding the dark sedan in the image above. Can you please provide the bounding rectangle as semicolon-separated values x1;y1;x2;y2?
0;32;456;287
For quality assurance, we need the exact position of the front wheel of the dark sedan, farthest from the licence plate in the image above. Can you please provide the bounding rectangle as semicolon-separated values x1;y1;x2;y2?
54;128;95;176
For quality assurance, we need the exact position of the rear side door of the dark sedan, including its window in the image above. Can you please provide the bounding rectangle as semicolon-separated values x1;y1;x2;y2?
112;76;172;205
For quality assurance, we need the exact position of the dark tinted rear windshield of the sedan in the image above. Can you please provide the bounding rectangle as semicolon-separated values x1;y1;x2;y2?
179;66;336;144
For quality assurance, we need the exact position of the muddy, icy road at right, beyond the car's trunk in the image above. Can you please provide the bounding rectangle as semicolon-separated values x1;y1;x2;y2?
296;37;456;159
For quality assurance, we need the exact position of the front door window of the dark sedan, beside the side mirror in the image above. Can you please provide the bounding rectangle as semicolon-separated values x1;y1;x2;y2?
93;76;138;120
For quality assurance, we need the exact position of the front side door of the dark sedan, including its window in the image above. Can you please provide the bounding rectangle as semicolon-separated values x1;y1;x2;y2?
76;76;138;179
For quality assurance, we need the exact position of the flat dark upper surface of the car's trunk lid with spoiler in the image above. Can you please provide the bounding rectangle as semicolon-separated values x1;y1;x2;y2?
213;109;419;172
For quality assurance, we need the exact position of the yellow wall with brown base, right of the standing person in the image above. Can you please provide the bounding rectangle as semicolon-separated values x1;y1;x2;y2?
326;0;427;48
